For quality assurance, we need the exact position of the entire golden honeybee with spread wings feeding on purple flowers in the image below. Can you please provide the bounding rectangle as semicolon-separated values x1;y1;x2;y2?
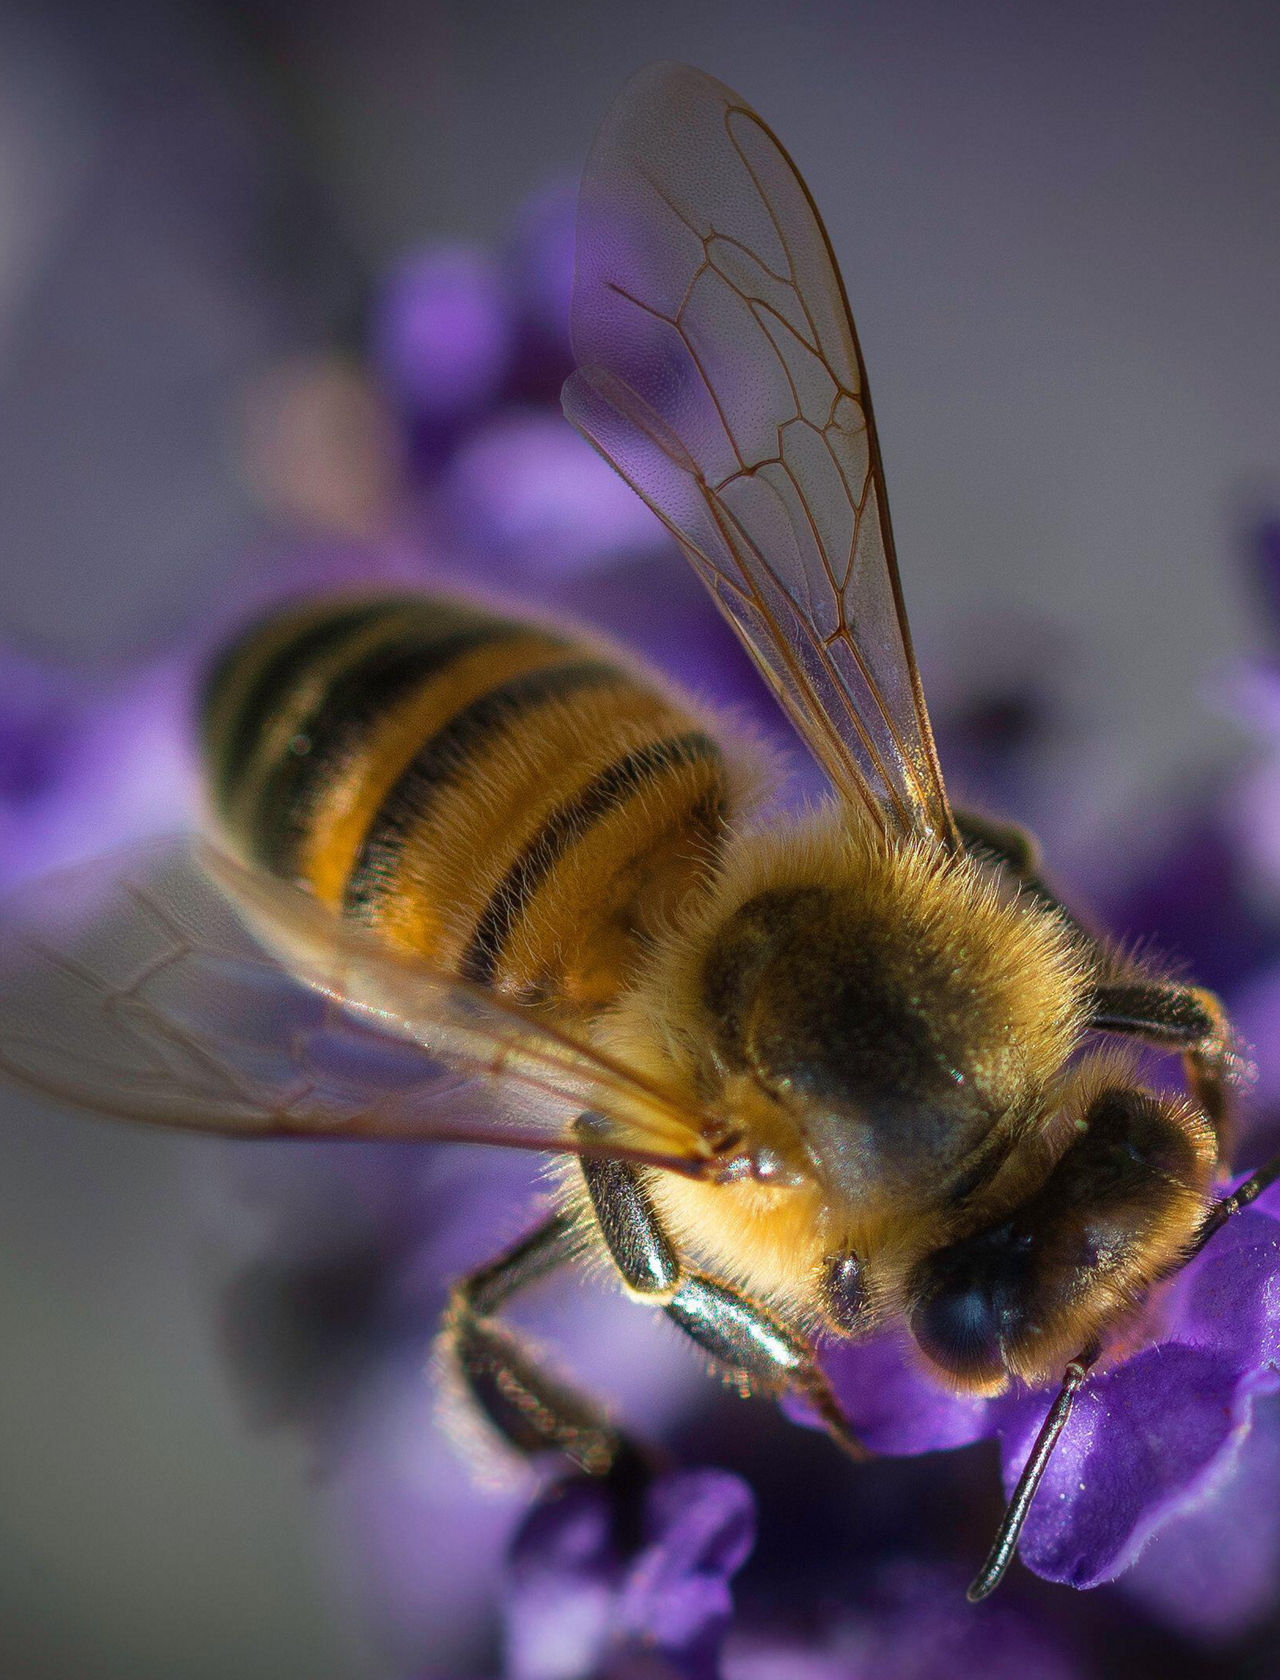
0;66;1280;1598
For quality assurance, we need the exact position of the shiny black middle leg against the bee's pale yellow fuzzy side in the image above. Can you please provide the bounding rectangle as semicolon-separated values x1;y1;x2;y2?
583;1159;870;1458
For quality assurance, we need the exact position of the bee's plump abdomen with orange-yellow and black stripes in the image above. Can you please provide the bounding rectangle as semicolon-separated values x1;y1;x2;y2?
203;596;727;1010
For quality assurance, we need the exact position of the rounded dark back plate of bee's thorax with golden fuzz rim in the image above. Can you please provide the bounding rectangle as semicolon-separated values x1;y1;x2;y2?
688;852;1080;1206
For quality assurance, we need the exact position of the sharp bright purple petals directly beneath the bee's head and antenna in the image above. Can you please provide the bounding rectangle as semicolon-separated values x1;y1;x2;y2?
788;1196;1280;1611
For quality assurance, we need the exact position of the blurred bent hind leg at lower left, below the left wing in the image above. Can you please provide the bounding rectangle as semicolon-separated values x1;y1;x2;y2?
442;1213;640;1475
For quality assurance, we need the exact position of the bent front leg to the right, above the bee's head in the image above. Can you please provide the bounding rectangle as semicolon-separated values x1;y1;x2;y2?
1089;979;1238;1161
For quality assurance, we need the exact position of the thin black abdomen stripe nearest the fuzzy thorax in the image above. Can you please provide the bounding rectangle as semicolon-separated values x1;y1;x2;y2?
462;729;721;986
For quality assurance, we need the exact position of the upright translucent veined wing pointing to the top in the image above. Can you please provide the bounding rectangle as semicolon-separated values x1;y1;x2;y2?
563;64;954;843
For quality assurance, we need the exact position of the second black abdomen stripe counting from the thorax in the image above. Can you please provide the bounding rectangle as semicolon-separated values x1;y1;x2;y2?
343;659;622;917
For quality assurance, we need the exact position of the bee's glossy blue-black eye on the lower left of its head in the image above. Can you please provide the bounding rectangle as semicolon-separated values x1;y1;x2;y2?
910;1225;1028;1383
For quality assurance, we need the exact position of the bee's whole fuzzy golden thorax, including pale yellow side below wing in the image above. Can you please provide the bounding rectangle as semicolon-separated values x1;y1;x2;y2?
601;806;1092;1307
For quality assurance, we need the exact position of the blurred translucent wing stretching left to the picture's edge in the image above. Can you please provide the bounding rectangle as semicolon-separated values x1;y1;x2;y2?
0;840;711;1176
